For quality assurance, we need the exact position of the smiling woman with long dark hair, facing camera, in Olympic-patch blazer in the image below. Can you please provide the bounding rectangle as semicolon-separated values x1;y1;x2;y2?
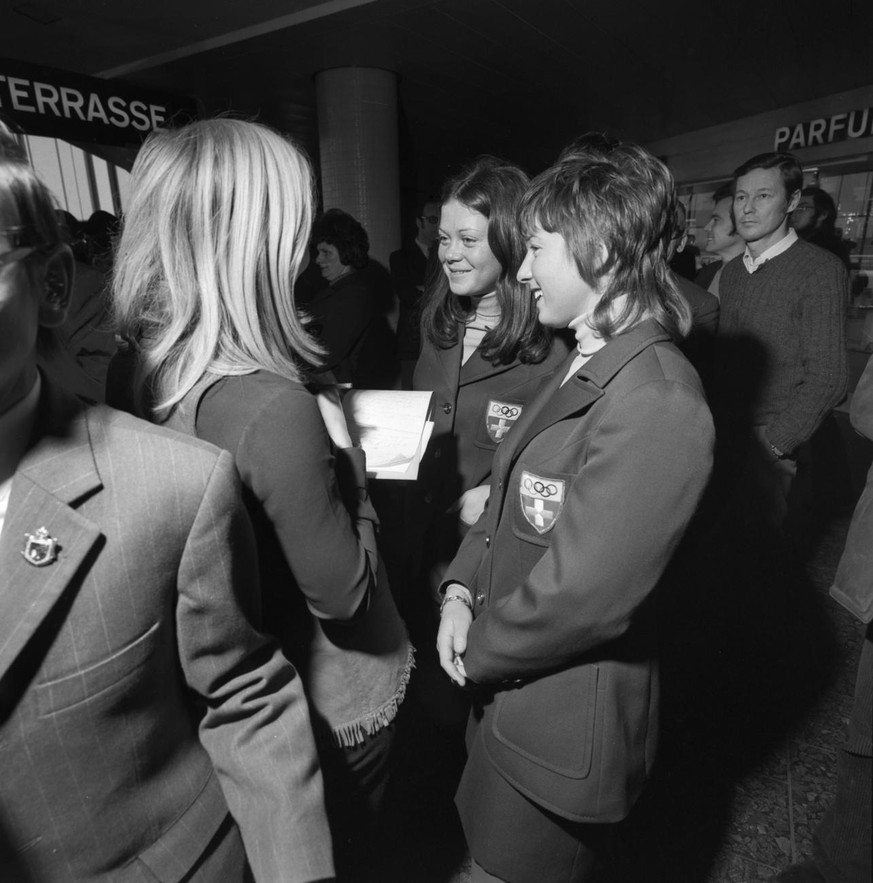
405;157;569;628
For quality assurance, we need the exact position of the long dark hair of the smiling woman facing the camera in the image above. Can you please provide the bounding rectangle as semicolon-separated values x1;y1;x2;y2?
421;156;552;365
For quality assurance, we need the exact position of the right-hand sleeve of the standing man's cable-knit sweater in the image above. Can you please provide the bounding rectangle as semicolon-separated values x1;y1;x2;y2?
767;252;848;452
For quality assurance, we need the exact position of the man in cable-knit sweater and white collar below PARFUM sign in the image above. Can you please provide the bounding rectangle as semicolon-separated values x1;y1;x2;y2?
718;153;848;526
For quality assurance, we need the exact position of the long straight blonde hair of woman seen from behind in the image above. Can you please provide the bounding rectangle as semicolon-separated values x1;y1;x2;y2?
112;119;322;418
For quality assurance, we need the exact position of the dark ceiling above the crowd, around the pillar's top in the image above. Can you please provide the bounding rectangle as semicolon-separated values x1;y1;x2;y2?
0;0;873;192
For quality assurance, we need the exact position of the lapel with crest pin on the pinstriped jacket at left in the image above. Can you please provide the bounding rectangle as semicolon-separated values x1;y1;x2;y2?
0;390;101;678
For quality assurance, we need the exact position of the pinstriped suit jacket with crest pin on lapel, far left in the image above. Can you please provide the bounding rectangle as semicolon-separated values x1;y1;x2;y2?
0;389;332;883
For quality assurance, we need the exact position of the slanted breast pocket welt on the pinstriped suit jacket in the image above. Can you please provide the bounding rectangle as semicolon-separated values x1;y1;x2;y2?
35;622;160;717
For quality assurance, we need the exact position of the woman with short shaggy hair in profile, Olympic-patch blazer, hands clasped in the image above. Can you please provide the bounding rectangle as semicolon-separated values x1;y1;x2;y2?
438;140;714;883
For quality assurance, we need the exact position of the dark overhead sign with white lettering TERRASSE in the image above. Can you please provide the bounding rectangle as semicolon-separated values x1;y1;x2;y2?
0;58;197;145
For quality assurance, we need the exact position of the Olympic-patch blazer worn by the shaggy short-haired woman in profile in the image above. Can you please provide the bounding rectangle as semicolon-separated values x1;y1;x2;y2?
446;321;714;822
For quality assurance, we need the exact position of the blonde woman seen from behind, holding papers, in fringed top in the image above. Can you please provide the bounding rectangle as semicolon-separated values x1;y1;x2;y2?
113;119;412;880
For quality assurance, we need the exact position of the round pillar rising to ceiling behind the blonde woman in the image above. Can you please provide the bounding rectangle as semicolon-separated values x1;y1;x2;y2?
315;67;400;267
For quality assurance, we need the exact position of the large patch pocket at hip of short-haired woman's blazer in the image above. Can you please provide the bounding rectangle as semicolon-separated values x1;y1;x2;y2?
491;665;600;779
